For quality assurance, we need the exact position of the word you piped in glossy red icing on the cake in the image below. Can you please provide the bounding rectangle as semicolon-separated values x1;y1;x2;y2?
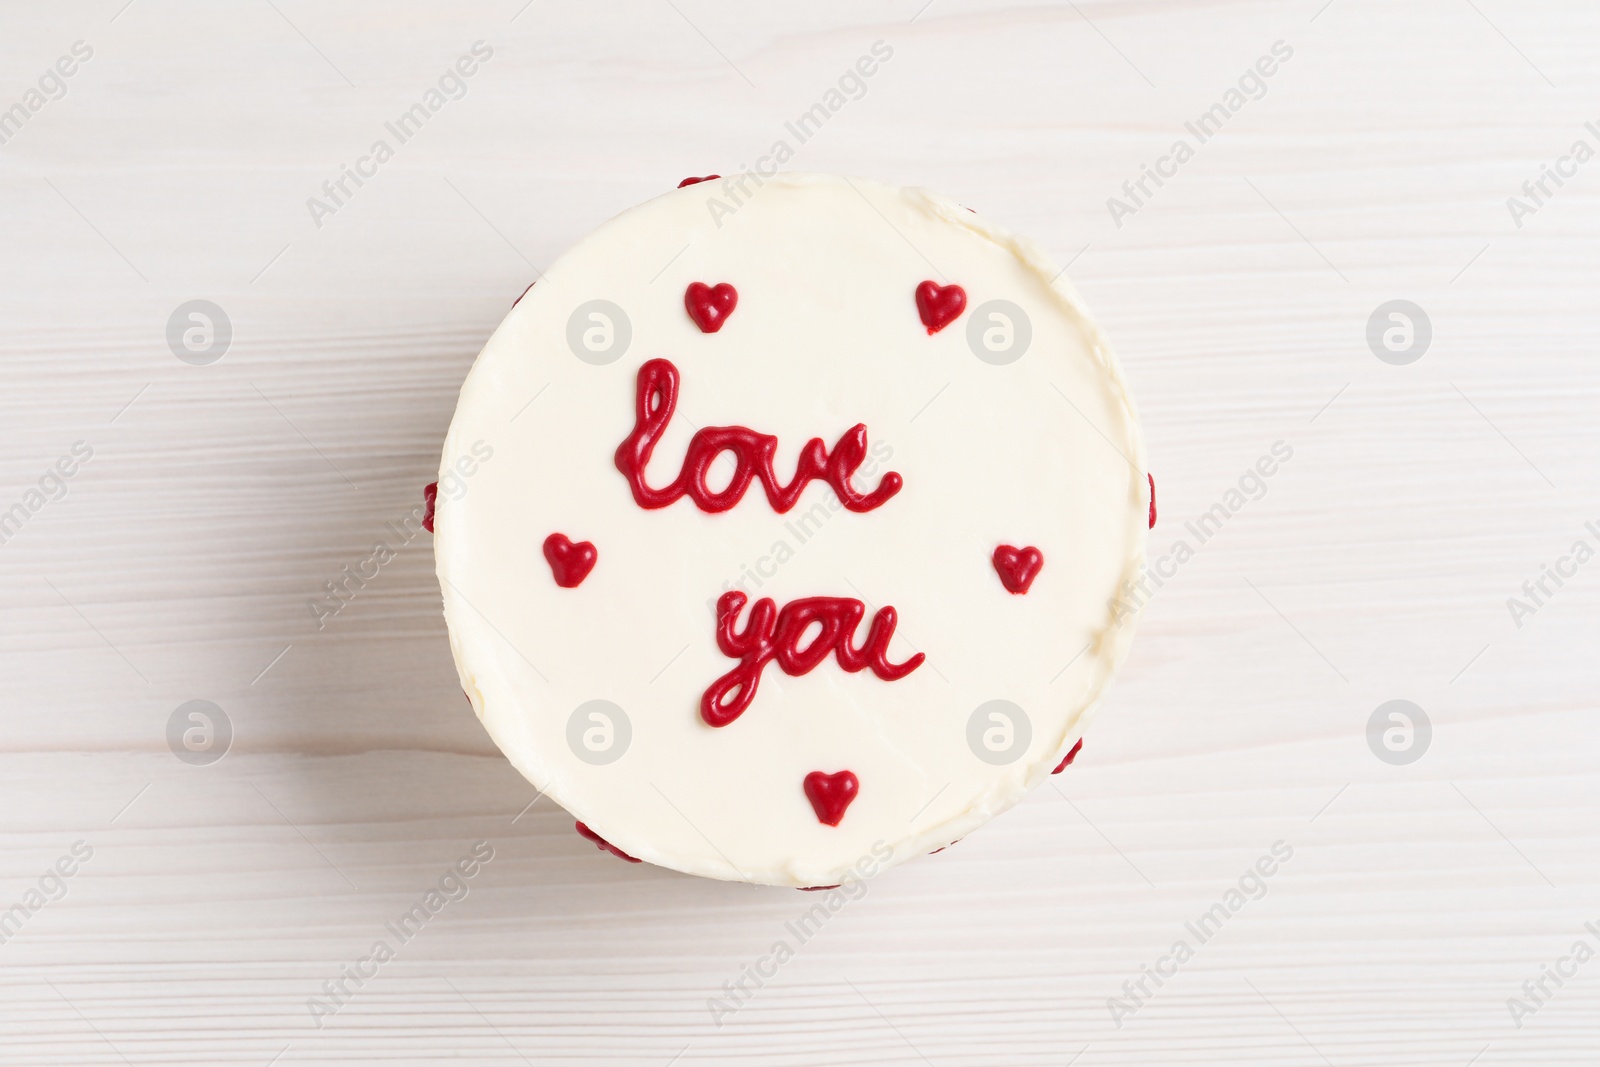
701;590;926;726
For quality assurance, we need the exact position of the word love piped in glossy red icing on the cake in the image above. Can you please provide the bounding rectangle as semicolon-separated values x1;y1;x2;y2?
616;360;902;512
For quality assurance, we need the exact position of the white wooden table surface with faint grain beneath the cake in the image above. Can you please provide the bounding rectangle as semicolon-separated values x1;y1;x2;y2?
0;0;1600;1067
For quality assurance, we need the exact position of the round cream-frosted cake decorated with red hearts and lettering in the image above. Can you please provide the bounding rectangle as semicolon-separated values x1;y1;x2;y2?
430;174;1155;888
